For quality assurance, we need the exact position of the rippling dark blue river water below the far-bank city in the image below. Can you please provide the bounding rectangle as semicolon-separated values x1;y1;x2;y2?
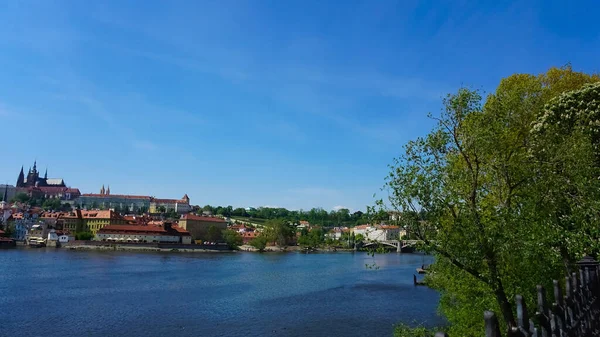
0;248;442;337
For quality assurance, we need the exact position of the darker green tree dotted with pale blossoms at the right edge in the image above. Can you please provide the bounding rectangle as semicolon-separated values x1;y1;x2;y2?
531;82;600;260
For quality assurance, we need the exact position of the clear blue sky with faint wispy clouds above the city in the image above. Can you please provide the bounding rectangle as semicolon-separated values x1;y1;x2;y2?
0;0;600;210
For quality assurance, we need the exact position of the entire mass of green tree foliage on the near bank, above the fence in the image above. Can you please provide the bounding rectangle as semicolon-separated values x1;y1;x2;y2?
384;67;600;336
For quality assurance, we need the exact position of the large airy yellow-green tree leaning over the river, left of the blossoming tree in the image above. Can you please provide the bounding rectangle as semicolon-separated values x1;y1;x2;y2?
380;67;597;336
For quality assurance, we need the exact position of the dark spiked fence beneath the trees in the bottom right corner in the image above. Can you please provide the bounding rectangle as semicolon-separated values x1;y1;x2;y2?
435;256;600;337
